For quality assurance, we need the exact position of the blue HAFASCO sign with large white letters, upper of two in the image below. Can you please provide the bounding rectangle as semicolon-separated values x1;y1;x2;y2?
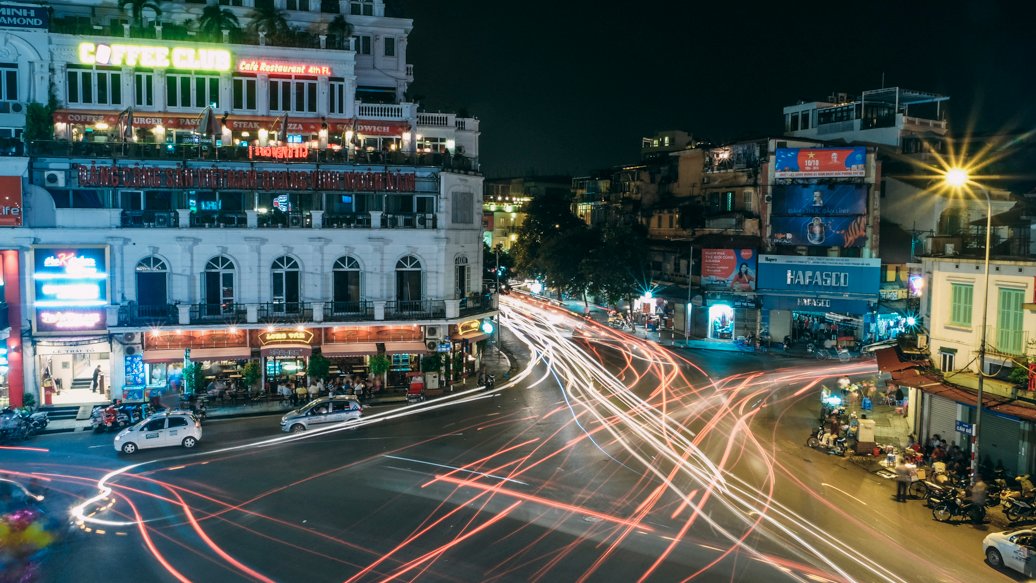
758;255;882;300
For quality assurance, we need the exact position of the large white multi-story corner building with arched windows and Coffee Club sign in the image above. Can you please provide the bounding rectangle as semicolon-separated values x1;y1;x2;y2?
0;0;495;402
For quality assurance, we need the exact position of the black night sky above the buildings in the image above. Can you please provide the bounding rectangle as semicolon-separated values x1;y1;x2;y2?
399;0;1036;177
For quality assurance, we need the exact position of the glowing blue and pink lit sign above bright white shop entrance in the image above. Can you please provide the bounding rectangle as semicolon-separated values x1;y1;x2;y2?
31;245;109;332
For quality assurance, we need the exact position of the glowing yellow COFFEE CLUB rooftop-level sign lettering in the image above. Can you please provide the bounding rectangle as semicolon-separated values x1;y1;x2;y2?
79;42;230;71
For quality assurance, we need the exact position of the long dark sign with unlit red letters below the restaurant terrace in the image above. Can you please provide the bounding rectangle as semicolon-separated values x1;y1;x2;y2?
77;164;416;193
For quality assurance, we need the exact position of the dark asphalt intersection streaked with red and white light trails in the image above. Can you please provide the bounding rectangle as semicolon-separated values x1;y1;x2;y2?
0;299;1012;582
